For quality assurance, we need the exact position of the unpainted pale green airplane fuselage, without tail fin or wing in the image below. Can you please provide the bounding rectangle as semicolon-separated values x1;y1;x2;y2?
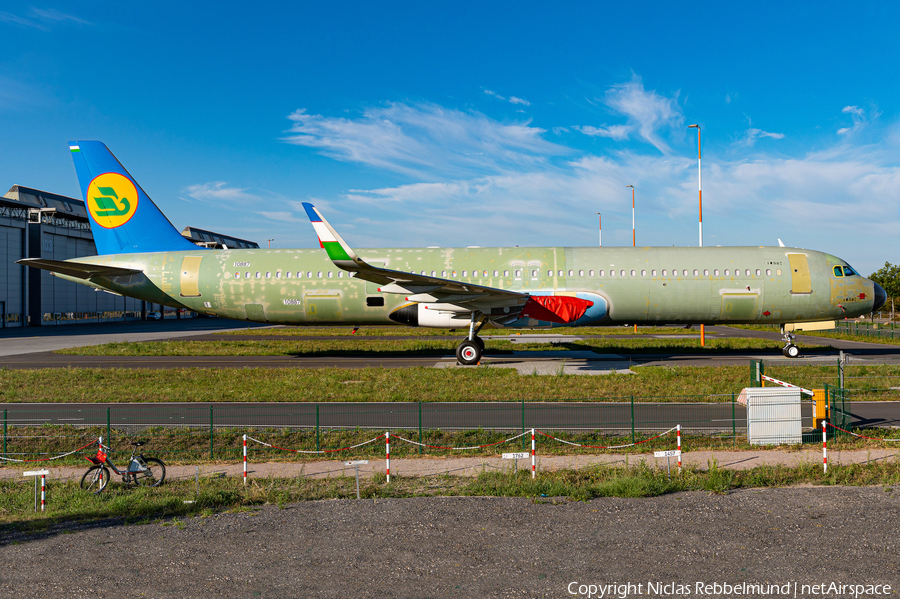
63;247;875;327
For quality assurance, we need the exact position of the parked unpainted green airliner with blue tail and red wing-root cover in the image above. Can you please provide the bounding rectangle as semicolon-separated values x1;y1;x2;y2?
19;141;886;365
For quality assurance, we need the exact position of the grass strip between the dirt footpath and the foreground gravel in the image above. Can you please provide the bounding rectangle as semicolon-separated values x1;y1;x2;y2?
0;460;900;528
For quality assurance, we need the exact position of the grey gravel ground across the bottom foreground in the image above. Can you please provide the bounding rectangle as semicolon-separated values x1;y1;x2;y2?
0;487;900;599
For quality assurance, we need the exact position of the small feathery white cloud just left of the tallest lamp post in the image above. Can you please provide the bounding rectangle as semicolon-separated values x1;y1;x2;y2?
579;75;684;154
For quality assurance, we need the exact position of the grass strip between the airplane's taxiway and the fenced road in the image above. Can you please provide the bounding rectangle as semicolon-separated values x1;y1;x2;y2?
0;365;900;403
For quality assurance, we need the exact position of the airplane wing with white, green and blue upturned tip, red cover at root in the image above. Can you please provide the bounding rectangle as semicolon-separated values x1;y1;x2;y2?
303;202;593;324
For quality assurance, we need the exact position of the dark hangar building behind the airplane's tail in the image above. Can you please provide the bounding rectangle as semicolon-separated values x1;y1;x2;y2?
0;185;259;328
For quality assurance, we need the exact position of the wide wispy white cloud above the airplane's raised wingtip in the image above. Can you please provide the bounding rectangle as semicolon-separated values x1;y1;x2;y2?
284;103;570;178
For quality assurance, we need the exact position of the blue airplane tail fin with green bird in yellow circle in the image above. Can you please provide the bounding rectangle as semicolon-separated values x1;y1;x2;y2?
69;141;201;255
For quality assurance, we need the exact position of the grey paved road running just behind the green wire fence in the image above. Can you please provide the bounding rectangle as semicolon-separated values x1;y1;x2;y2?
0;401;900;433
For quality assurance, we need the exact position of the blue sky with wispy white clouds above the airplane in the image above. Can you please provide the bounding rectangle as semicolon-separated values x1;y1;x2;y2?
0;2;900;274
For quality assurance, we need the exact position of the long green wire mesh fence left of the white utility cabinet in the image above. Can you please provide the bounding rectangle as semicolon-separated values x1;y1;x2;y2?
0;394;828;459
